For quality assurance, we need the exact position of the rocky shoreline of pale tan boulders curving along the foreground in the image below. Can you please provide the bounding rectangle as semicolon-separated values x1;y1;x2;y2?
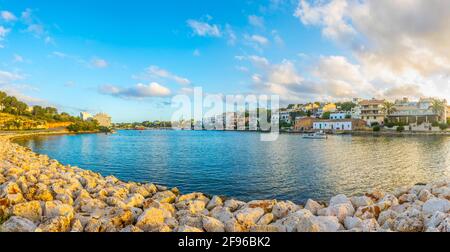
0;135;450;232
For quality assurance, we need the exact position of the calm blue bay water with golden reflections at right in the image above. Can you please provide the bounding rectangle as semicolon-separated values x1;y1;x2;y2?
16;131;450;203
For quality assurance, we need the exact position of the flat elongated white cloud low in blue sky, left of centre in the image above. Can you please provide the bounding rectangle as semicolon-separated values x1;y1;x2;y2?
99;82;171;98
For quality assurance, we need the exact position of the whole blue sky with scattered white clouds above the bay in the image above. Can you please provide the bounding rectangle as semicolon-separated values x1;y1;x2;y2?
0;0;450;122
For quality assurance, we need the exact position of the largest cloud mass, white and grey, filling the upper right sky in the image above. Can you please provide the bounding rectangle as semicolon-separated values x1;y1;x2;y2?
294;0;450;99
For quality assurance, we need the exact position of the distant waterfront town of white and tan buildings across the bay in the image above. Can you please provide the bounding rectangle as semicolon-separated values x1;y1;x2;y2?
112;98;450;132
